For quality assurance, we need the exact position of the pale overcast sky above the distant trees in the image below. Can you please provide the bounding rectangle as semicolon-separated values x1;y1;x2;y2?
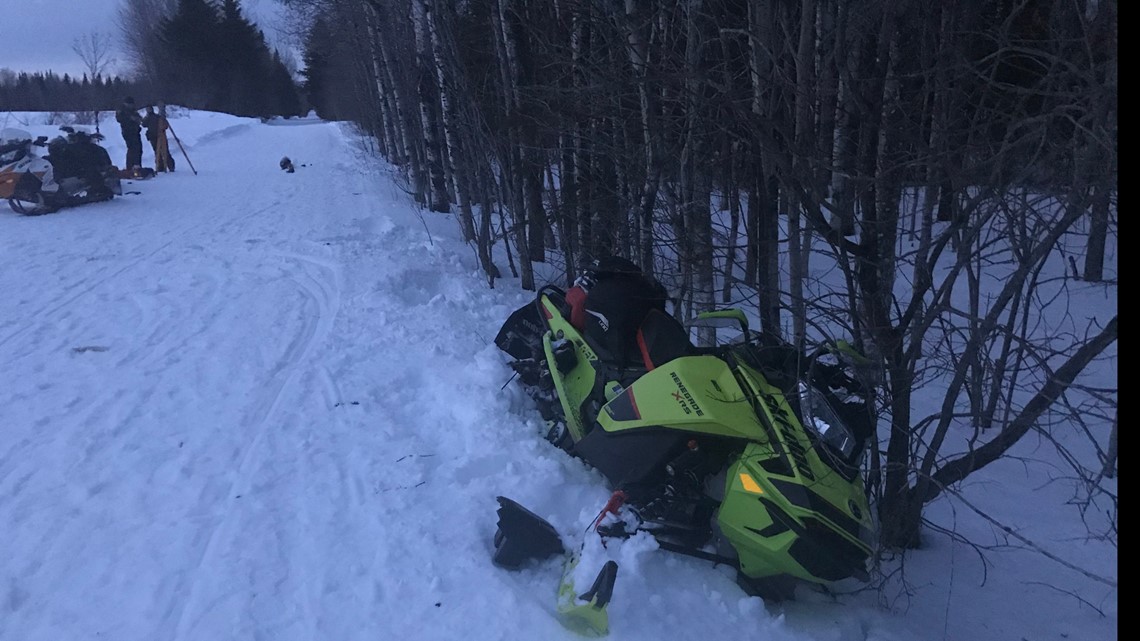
0;0;294;75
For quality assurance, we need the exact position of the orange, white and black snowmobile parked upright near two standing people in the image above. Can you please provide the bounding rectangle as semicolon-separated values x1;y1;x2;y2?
0;127;123;216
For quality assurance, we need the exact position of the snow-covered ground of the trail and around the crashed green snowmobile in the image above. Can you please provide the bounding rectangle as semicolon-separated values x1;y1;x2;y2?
0;113;1117;641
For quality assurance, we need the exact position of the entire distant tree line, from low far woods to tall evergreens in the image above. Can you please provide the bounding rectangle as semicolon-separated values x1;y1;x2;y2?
0;0;298;117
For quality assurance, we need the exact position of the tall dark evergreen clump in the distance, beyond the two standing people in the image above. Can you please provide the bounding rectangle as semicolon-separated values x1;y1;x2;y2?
119;0;303;117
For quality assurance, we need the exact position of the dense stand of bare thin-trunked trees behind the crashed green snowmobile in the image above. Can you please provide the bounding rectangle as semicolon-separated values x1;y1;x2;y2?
296;0;1118;574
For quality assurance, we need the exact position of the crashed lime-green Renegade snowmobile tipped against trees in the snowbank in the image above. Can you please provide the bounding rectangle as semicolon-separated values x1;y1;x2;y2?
494;277;873;633
